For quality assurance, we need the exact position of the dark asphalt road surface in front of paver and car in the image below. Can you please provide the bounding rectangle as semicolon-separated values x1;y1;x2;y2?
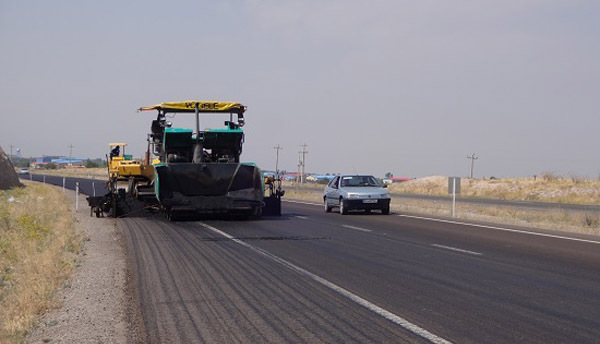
118;202;600;343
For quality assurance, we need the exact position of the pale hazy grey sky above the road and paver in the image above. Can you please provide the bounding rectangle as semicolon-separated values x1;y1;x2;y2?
0;0;600;178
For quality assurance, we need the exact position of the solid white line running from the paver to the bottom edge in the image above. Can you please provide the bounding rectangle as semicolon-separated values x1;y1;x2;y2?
198;222;451;344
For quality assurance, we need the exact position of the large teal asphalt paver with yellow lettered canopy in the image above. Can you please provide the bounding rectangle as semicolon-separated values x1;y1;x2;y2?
134;101;283;219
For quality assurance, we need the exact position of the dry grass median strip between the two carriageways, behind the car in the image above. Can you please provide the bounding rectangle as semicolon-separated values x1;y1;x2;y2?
284;186;600;235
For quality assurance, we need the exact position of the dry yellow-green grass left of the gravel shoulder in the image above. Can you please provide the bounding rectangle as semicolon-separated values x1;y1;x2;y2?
0;181;82;343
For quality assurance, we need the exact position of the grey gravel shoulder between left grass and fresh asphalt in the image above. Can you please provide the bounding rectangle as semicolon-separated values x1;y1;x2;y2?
25;188;141;343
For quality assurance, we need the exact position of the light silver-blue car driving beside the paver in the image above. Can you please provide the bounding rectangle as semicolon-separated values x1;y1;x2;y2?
323;175;390;215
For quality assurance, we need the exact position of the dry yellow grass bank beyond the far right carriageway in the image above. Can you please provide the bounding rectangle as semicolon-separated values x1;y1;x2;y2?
389;172;600;204
